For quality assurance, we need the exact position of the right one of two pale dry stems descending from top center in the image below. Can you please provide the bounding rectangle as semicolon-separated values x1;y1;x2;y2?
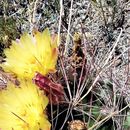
64;0;73;55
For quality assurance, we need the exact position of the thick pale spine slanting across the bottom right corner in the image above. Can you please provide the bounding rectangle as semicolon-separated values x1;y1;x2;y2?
88;104;130;130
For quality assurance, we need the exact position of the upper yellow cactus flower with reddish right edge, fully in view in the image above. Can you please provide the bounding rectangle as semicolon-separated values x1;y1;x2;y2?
1;29;58;78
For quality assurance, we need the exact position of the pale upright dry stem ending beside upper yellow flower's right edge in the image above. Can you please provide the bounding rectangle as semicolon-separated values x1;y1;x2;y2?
57;0;63;44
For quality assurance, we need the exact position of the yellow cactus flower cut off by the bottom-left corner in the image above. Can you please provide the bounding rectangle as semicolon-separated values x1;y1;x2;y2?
0;81;51;130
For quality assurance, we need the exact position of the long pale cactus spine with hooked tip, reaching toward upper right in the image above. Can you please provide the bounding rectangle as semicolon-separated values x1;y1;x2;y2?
77;28;122;104
